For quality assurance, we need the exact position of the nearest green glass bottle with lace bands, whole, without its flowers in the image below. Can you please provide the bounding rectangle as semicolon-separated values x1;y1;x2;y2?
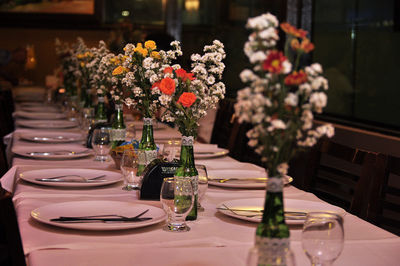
255;175;291;266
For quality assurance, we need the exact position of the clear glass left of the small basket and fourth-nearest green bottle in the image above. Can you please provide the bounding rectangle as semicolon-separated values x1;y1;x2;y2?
92;127;111;162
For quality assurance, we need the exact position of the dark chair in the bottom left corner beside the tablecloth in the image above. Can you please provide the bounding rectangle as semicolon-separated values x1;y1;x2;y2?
0;186;26;266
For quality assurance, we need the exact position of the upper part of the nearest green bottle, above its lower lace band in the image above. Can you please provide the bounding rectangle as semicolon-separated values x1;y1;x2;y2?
256;177;290;238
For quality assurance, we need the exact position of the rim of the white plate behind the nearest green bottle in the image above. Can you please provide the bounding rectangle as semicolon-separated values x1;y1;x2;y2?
216;197;347;225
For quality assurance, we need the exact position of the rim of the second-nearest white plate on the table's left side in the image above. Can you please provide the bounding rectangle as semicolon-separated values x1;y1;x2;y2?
18;168;123;188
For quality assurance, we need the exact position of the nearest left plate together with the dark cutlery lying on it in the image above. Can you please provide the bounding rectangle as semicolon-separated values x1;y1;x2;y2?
31;200;166;231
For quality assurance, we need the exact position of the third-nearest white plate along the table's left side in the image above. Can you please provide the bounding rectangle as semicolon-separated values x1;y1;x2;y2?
12;145;92;160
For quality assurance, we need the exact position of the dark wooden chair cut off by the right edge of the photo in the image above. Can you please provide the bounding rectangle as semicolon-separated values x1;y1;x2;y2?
367;154;400;236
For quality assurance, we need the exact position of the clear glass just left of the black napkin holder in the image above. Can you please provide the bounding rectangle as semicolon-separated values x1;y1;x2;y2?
120;150;142;191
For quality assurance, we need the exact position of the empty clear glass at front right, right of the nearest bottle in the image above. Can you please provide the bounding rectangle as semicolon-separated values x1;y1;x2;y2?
302;212;344;266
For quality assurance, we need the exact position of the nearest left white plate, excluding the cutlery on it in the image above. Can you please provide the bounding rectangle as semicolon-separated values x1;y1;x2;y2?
31;201;166;231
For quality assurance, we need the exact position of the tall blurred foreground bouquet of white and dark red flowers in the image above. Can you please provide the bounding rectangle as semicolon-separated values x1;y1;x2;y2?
235;13;334;176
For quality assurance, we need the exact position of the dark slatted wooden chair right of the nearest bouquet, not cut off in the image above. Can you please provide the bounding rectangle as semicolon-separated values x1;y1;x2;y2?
294;139;378;219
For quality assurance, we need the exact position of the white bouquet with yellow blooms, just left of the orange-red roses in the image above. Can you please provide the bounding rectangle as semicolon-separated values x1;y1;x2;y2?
112;40;182;118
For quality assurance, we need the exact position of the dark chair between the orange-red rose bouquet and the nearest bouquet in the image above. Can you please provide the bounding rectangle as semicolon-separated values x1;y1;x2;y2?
210;99;236;148
